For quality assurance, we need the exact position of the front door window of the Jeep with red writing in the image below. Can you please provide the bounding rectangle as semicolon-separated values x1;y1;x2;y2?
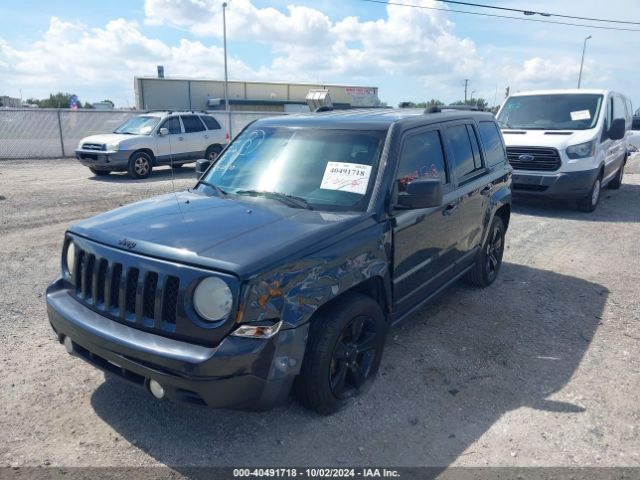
396;131;447;192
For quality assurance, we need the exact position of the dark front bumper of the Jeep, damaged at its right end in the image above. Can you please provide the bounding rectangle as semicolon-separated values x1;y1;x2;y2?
47;281;308;410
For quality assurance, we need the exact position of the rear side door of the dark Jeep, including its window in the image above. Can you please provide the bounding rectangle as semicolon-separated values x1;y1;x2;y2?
444;120;493;271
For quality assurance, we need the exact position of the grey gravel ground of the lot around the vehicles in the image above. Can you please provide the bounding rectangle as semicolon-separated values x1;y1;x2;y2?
0;156;640;472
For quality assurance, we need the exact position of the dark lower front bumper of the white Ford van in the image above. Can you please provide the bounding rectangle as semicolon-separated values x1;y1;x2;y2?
512;168;600;199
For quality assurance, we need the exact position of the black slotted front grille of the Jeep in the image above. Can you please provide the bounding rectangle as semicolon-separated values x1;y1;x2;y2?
73;247;180;328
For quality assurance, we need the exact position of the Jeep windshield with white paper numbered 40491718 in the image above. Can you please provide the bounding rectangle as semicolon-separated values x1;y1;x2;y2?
198;126;386;211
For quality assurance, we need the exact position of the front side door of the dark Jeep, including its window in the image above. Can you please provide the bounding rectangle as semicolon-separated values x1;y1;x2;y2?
393;129;460;317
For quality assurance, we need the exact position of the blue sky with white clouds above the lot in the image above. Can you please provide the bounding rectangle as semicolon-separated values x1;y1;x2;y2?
0;0;640;107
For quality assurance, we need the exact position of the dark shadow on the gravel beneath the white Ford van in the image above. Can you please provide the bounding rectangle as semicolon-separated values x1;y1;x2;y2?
512;183;640;222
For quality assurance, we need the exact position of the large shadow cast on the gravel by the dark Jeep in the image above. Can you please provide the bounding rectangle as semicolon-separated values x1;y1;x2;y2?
91;264;609;468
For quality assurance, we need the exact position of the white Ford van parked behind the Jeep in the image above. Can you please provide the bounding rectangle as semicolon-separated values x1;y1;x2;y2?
497;89;632;212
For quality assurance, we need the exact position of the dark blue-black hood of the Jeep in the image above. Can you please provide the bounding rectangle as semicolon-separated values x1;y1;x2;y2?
70;191;370;276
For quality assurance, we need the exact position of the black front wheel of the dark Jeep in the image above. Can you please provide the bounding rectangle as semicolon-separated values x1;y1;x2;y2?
294;293;387;415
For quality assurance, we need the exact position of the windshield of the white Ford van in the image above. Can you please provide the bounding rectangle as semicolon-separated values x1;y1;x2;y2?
498;94;602;130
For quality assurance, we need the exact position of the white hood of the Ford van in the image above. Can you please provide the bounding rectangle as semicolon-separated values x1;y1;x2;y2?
502;127;600;150
